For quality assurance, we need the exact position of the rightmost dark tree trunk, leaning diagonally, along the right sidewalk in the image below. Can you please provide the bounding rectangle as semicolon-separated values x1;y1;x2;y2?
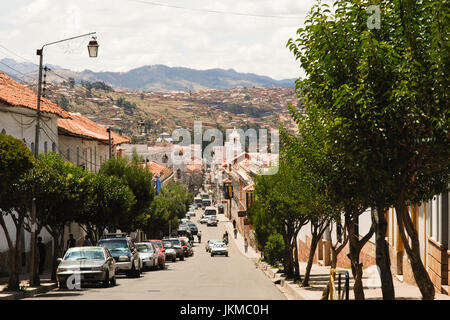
395;201;435;300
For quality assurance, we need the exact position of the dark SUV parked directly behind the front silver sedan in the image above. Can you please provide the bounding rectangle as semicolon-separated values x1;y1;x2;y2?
97;234;142;278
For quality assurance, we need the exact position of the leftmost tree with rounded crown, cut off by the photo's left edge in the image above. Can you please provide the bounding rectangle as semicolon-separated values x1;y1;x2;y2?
0;133;34;290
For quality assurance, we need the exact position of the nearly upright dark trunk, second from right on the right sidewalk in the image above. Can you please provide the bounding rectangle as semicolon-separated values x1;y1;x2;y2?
372;203;395;300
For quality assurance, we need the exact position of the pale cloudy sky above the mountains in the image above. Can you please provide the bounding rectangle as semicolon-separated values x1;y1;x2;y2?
0;0;315;79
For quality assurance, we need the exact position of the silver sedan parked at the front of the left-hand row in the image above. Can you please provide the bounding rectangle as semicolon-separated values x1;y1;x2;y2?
56;247;116;289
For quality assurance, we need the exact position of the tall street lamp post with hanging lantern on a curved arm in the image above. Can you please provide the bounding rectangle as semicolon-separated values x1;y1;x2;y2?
30;32;99;286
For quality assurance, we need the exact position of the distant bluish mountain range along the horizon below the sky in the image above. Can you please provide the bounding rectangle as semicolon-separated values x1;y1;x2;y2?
0;58;295;91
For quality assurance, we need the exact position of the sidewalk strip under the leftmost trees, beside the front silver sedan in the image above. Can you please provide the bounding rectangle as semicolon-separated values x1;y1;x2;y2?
0;272;58;300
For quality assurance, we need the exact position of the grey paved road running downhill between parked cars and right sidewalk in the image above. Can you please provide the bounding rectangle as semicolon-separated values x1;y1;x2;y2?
25;211;286;300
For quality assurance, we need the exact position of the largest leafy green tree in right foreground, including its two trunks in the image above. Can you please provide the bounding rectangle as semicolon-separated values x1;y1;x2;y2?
288;0;450;299
